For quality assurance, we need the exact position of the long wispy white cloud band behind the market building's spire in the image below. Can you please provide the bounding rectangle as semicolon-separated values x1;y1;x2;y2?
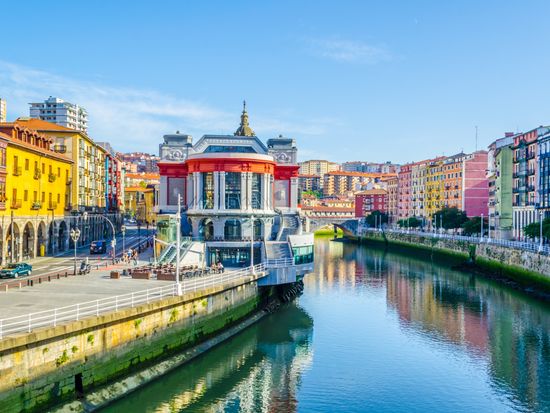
0;61;329;152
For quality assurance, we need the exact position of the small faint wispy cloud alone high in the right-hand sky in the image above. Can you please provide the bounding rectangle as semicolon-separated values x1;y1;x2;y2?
310;39;393;64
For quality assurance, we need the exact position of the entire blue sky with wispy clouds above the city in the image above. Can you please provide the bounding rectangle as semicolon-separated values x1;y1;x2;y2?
0;0;550;162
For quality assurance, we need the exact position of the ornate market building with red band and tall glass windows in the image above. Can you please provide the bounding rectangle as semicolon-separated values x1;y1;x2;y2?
157;101;313;278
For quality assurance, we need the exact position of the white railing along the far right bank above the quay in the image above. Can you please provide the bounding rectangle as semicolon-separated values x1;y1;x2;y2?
359;227;550;255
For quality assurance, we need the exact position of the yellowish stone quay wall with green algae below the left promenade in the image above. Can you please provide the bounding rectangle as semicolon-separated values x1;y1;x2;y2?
0;276;261;412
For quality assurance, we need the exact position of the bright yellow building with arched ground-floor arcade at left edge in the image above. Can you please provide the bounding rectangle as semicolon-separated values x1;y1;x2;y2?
0;123;73;265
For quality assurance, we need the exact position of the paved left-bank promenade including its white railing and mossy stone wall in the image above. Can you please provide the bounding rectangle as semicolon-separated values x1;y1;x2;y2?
0;249;271;411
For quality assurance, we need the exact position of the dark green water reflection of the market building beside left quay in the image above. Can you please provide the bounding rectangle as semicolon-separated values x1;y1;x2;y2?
104;304;313;412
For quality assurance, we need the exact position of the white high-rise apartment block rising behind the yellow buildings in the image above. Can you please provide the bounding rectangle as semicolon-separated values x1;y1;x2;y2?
29;96;88;133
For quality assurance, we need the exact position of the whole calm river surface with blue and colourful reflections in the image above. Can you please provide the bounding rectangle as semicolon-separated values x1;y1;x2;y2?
104;239;550;413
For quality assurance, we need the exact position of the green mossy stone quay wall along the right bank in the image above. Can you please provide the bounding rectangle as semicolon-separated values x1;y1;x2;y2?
358;232;550;290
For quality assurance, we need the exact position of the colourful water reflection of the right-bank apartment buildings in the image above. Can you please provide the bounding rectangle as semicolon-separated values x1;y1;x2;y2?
306;238;550;411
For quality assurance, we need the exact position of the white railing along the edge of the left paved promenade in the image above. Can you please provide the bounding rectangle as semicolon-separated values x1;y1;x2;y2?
0;263;267;340
